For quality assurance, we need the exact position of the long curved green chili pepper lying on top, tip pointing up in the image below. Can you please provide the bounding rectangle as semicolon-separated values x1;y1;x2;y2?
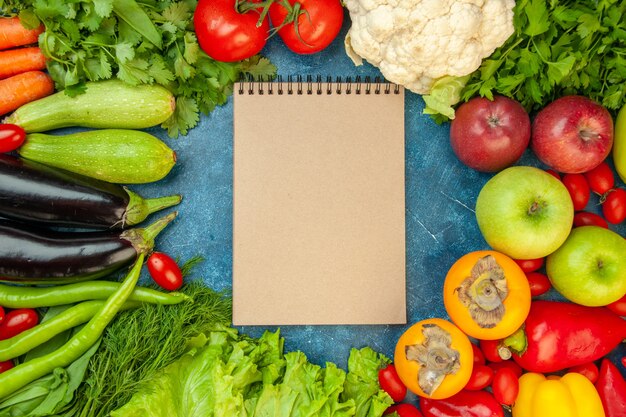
0;253;145;398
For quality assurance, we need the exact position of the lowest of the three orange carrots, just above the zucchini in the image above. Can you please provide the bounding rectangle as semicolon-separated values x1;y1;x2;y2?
0;71;54;116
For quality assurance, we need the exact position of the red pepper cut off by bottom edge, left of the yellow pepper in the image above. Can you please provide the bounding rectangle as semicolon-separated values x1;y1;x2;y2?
420;390;504;417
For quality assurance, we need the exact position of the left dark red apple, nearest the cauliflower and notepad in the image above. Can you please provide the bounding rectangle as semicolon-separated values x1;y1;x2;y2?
450;96;530;172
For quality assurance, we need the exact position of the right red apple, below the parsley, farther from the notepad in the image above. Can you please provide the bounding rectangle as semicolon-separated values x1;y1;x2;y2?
530;96;613;174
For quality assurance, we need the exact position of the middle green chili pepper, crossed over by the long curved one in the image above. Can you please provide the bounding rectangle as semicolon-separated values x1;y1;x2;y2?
0;300;141;362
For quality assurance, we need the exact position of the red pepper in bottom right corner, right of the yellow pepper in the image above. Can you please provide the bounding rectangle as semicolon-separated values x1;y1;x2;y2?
596;358;626;417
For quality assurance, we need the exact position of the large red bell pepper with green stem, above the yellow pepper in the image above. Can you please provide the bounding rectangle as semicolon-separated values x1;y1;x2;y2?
504;300;626;373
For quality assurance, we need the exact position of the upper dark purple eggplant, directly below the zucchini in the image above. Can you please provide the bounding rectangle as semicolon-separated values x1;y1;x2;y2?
0;154;181;230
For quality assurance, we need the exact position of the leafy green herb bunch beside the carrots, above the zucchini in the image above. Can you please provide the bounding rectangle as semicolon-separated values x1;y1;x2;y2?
0;0;276;137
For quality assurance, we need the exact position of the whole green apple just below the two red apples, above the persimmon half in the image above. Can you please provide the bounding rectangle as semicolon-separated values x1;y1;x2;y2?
476;166;574;259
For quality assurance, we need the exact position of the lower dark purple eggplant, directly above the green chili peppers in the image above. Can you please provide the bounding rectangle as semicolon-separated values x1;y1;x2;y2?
0;212;177;284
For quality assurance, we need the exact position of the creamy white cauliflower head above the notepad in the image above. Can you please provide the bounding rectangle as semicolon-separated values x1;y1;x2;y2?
345;0;515;94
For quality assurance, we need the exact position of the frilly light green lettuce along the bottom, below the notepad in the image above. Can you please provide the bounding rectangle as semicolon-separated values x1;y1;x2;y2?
111;328;393;417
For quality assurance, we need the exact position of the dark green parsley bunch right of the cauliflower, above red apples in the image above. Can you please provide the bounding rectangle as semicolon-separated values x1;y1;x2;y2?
461;0;626;112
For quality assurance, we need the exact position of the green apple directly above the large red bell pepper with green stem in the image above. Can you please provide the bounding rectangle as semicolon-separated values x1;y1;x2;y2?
546;226;626;307
